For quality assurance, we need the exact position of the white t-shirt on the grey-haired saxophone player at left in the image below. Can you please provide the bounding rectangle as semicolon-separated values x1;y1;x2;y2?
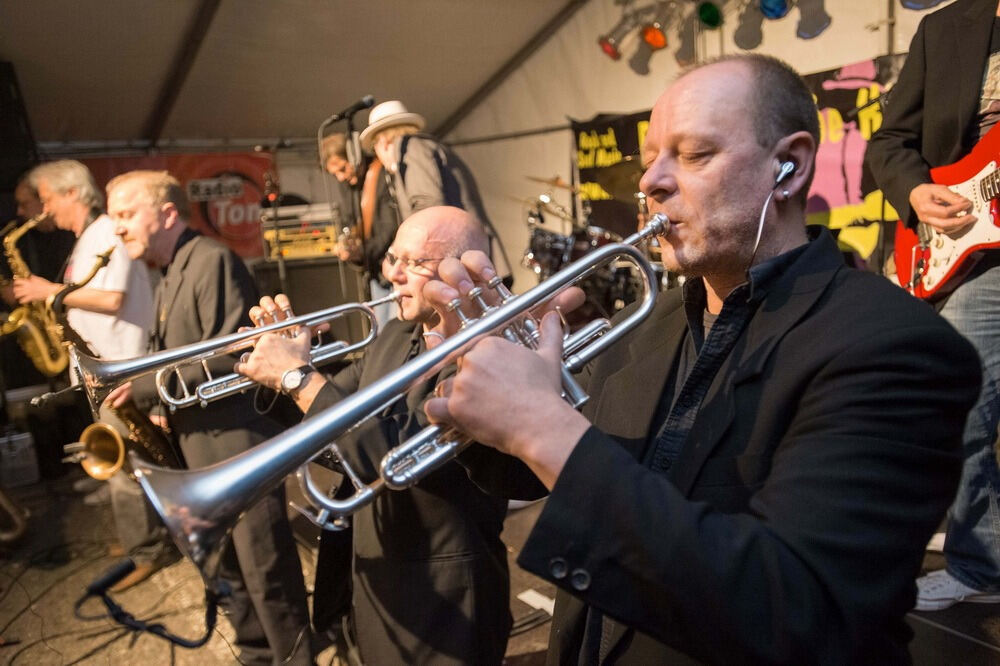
63;215;154;360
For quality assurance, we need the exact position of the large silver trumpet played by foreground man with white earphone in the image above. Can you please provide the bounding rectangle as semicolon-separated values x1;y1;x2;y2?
133;210;667;598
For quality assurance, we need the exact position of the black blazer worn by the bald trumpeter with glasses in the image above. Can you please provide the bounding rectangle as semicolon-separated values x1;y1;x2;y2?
306;320;511;665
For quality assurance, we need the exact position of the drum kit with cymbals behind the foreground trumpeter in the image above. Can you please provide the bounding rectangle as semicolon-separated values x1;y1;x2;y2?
522;157;674;323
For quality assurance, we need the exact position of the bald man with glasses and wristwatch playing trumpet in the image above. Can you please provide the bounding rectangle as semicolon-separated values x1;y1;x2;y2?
236;206;511;664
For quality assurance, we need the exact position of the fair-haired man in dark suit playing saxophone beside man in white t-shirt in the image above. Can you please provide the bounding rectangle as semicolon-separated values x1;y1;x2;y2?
108;171;313;664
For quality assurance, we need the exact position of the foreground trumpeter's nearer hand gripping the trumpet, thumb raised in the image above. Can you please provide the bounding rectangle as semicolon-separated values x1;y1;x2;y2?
424;312;590;489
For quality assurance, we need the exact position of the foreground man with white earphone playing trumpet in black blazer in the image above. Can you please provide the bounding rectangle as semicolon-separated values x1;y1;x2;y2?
424;55;979;664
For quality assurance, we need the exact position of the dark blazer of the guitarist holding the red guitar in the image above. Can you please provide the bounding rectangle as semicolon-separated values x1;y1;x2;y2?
865;0;997;227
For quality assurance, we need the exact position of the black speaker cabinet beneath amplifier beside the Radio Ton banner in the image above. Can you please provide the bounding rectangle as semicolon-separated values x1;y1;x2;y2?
253;257;368;342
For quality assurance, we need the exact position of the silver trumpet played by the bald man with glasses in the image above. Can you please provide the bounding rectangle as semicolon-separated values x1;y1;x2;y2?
65;292;399;414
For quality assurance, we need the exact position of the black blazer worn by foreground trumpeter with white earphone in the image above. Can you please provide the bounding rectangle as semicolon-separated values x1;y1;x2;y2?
494;231;979;664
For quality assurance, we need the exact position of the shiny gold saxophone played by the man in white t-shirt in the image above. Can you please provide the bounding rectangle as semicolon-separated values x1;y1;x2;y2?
0;213;69;377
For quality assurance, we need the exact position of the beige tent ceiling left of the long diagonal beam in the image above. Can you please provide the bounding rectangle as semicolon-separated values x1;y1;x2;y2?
0;0;586;153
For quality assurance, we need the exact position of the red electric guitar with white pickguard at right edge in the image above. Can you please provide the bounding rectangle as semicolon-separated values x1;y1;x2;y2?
894;123;1000;299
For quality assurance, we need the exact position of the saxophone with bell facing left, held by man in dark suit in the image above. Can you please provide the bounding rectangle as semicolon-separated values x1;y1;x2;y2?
48;246;184;481
